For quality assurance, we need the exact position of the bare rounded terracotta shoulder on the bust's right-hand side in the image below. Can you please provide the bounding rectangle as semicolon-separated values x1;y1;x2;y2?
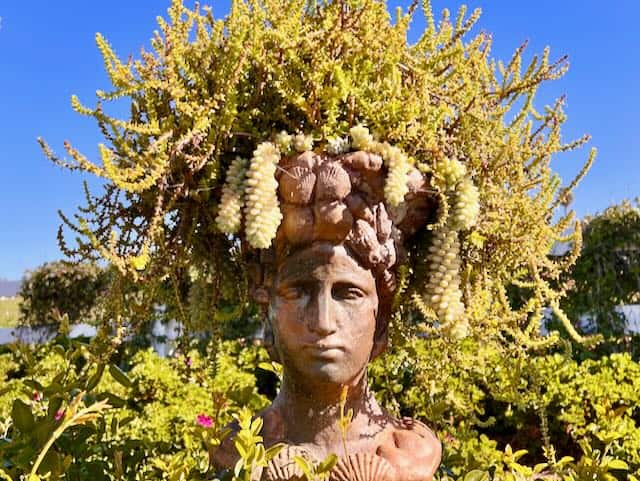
376;418;442;481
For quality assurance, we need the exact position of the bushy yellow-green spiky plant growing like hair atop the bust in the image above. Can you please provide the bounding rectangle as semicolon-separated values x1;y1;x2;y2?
42;0;594;348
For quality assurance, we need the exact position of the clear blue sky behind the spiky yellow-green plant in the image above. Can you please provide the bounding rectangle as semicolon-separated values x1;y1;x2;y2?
0;0;640;279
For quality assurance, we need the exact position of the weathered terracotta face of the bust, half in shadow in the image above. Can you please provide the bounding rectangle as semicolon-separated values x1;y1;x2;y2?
270;243;378;385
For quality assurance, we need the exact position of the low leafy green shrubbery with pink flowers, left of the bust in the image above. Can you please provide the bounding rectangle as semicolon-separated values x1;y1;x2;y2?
0;337;268;480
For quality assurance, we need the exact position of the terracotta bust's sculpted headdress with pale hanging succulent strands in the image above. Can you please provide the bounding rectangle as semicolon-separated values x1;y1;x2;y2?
216;126;479;336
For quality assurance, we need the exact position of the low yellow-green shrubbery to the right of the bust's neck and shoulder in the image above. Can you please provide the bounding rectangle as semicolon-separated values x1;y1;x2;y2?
369;339;640;479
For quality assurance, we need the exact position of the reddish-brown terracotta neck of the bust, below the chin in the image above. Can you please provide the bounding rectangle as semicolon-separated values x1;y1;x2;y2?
274;373;386;457
